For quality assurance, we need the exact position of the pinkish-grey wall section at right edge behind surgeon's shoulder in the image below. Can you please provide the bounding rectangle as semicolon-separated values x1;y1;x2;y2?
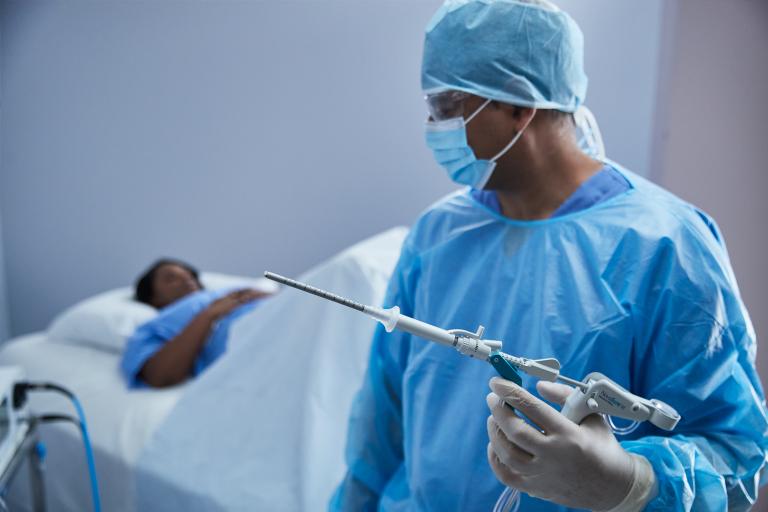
659;0;768;504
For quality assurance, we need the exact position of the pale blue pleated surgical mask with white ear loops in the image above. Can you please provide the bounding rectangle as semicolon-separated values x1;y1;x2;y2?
426;100;535;190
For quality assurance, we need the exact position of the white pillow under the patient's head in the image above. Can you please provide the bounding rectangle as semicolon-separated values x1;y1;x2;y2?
48;272;277;354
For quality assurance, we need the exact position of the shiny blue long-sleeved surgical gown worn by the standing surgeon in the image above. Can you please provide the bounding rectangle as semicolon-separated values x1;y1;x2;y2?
330;166;768;512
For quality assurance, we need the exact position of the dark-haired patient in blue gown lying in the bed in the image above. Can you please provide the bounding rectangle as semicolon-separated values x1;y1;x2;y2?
120;259;269;388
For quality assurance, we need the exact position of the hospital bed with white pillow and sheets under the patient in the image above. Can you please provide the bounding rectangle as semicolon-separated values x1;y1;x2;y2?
0;228;406;512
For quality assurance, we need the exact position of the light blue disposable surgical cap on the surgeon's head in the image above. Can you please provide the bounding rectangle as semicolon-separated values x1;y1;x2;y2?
421;0;587;112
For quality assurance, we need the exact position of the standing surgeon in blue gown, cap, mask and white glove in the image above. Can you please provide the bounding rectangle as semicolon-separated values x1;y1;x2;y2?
330;0;768;512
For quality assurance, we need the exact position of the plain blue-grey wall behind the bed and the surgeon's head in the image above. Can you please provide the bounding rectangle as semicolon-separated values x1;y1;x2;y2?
0;0;662;334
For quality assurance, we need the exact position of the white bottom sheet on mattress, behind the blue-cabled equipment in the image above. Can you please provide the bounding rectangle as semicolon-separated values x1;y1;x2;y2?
0;333;186;512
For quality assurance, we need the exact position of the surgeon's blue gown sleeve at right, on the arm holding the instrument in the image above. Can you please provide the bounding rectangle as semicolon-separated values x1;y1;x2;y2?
622;218;768;511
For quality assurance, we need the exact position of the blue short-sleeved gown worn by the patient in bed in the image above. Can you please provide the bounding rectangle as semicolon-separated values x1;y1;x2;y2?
120;289;259;388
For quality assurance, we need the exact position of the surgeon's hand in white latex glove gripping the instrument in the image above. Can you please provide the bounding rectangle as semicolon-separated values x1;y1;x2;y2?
486;377;656;511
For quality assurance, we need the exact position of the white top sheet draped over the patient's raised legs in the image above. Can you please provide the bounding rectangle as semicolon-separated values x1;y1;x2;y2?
136;228;407;512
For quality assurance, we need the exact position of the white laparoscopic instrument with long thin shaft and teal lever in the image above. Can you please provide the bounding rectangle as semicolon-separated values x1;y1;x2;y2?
264;272;680;431
